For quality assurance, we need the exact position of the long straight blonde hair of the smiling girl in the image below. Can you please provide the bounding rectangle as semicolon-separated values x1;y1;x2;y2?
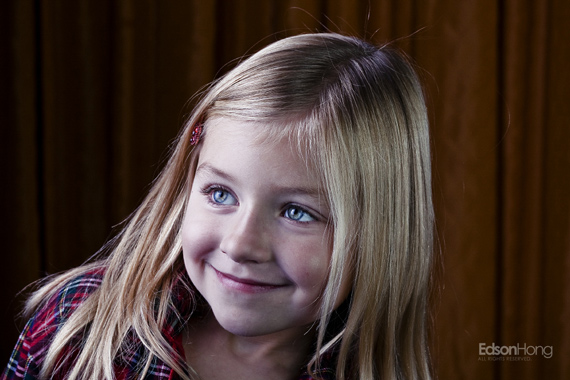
28;33;433;379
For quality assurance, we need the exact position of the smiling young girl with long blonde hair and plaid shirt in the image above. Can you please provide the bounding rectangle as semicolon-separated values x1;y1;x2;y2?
2;34;433;379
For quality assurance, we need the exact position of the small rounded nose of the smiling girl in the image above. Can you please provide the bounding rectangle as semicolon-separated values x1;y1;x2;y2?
220;209;272;263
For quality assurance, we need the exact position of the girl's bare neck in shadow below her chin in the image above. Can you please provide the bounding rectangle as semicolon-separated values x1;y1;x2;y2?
184;313;315;379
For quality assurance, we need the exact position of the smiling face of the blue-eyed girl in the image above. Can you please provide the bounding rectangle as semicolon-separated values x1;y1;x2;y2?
182;118;348;336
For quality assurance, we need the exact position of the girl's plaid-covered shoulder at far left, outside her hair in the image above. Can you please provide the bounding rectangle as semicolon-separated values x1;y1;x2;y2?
0;267;105;380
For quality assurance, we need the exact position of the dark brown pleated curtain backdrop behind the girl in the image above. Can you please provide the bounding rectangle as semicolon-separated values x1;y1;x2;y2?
0;0;570;380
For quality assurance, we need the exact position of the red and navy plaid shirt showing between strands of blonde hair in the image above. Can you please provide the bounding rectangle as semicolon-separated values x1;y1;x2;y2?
0;270;334;380
